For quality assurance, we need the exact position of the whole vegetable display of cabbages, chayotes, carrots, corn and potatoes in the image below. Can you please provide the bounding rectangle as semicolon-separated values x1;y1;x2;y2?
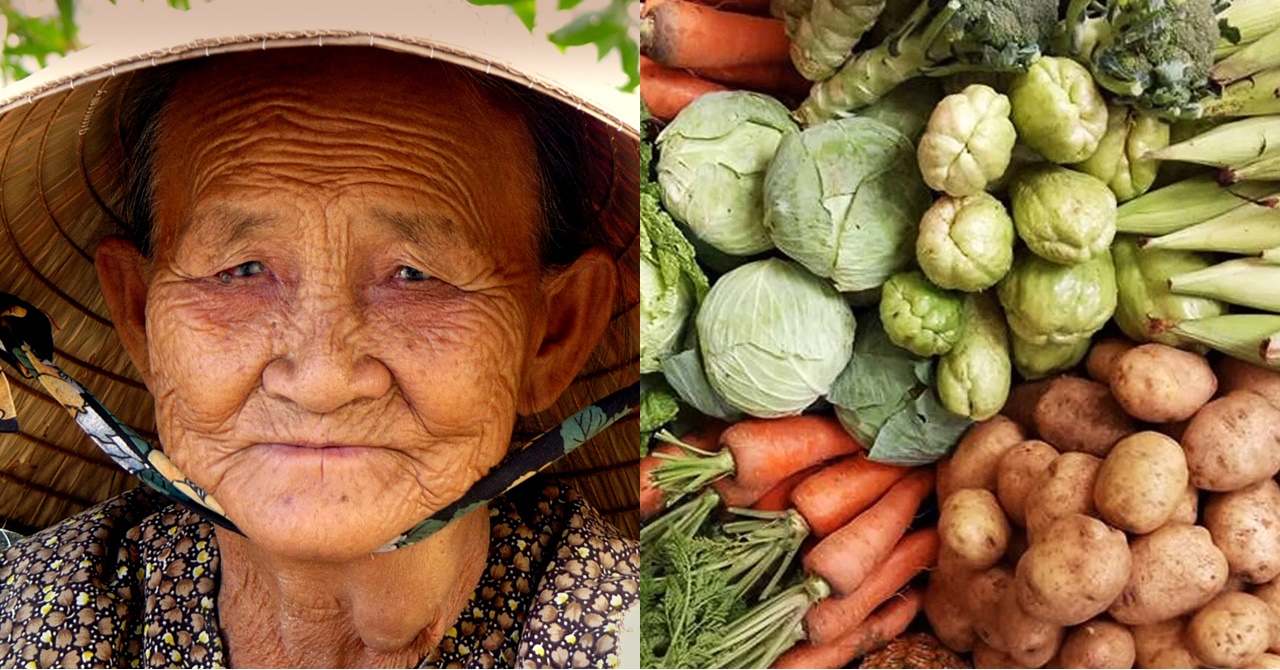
640;0;1280;667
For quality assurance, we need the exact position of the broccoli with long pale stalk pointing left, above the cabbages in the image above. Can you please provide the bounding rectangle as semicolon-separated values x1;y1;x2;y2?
795;0;1057;126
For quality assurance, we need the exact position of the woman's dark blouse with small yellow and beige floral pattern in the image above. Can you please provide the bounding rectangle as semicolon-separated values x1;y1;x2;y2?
0;479;640;667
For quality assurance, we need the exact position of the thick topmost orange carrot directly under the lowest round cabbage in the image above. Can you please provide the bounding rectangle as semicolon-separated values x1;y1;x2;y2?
721;414;861;487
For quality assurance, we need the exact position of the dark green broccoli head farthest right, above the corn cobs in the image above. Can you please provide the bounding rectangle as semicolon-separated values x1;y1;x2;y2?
1057;0;1220;117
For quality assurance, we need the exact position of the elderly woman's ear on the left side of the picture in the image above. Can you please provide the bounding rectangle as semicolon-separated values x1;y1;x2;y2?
93;236;151;380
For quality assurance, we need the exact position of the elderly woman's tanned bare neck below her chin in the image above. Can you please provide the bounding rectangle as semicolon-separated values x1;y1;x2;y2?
209;507;489;667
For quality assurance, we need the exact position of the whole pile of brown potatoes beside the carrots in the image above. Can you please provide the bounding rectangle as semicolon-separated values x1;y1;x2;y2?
924;339;1280;667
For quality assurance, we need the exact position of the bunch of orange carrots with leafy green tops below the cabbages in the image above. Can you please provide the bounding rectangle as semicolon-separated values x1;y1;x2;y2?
640;414;938;667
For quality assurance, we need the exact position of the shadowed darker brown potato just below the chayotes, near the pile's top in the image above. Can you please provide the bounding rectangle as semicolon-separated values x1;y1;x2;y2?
1034;375;1138;457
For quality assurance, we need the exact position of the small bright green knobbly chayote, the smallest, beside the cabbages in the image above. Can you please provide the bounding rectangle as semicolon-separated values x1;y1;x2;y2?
879;270;965;356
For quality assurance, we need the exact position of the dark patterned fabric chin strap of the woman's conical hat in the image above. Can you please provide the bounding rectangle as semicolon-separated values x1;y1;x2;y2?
0;293;640;552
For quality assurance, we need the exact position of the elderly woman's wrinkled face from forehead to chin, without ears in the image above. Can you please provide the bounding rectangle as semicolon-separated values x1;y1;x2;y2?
146;49;541;557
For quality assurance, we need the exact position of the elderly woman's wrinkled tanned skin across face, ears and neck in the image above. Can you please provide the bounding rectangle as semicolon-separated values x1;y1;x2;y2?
97;47;616;666
